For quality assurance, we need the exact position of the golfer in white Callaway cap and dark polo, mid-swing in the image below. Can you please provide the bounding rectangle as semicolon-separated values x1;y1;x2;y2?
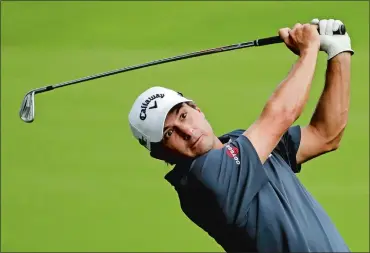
129;19;354;252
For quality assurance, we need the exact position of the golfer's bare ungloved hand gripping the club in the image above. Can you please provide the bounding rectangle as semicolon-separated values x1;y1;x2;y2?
279;23;320;56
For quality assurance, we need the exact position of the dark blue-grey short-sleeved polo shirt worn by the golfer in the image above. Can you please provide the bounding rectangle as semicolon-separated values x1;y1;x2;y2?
165;126;349;252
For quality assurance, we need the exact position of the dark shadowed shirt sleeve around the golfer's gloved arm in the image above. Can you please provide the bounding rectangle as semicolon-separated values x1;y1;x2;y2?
275;126;301;173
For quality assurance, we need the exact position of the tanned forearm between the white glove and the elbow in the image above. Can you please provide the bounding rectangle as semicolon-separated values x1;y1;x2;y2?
310;53;351;147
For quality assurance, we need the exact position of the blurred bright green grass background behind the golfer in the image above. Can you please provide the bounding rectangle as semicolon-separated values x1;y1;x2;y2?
1;1;369;252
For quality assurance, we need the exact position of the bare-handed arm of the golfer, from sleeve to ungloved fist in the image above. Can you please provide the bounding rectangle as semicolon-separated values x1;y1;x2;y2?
244;24;320;163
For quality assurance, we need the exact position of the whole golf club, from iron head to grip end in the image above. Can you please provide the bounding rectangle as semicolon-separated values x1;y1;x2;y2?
19;25;346;123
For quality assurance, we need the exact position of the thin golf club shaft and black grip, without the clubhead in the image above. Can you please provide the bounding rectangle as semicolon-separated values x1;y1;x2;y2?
35;36;282;93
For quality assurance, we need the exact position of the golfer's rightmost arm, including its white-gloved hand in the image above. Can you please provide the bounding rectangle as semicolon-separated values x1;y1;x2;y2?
296;19;354;164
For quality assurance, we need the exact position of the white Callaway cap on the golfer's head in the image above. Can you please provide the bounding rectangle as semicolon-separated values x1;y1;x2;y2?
129;86;192;150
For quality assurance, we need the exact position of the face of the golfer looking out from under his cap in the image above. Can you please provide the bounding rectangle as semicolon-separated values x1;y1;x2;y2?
163;103;216;157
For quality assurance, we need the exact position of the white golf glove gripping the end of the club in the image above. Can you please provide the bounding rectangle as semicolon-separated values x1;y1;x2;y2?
311;18;355;60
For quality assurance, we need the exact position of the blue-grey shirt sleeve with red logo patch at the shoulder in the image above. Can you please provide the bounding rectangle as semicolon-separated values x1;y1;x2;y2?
190;135;268;222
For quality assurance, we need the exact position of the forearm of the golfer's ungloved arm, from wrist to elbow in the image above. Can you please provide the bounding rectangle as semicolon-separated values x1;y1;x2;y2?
264;50;317;123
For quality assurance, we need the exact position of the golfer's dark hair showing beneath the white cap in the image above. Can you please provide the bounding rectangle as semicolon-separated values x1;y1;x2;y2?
150;102;197;165
